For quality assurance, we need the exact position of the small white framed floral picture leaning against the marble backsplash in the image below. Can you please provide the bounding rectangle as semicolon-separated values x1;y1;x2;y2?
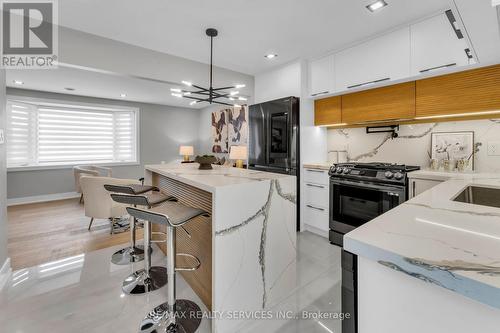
431;132;475;171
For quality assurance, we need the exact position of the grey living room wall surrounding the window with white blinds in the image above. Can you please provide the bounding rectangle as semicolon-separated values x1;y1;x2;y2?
7;88;200;199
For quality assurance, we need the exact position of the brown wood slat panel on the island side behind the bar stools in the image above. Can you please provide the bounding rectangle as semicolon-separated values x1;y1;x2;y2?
153;174;212;310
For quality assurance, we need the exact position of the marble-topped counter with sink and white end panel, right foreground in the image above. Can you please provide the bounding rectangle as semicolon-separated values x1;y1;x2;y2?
344;174;500;333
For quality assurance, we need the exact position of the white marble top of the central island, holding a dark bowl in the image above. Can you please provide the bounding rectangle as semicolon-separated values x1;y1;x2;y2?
145;163;295;193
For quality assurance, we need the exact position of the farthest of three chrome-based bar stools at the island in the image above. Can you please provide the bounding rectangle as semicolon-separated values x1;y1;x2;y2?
104;184;175;265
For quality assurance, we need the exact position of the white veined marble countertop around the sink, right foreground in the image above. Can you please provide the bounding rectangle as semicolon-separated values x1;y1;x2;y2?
344;174;500;308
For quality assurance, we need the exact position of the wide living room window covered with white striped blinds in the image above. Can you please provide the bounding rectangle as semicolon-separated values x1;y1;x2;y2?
7;100;137;168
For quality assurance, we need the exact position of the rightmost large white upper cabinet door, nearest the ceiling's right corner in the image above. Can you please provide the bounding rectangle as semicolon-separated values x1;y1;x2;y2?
410;11;474;76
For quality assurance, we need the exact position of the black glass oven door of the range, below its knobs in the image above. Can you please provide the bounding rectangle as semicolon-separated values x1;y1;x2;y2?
330;179;405;244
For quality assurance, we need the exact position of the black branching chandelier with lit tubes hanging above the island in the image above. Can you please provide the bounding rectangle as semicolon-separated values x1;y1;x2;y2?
170;28;246;106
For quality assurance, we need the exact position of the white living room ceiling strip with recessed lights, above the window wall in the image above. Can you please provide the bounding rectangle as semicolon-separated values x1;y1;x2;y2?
6;67;213;108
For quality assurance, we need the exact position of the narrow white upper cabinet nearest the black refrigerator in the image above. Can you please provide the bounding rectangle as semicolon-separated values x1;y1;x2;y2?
309;55;335;97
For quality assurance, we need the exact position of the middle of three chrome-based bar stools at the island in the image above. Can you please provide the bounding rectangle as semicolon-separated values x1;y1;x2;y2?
107;192;176;295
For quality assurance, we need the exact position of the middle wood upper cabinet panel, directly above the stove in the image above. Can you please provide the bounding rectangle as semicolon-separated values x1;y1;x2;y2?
342;82;415;124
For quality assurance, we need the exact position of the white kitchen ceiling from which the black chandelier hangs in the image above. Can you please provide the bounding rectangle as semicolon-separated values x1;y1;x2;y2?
59;0;449;74
